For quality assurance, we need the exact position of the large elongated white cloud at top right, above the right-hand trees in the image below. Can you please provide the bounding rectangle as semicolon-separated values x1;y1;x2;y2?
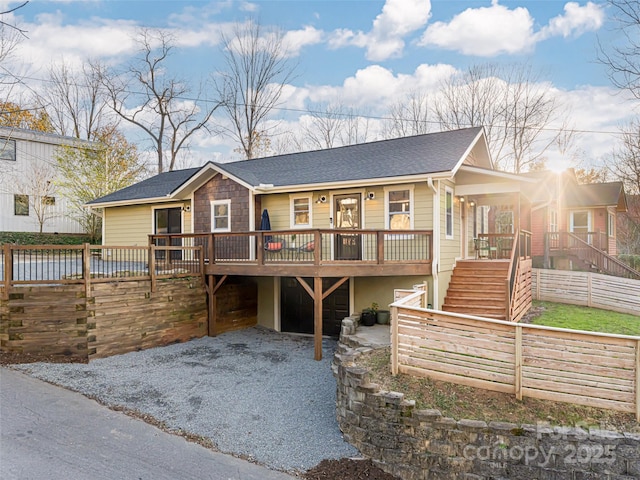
419;0;604;57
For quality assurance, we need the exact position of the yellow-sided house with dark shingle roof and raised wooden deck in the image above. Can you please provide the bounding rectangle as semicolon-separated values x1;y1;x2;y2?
88;128;534;360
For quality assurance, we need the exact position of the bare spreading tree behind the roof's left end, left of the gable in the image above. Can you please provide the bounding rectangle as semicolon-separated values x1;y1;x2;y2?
101;29;220;173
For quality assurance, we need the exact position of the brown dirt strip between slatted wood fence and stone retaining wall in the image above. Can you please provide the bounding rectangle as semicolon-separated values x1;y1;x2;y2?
358;348;640;433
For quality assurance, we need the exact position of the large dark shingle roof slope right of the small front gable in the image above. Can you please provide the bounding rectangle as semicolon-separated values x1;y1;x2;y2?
215;127;482;187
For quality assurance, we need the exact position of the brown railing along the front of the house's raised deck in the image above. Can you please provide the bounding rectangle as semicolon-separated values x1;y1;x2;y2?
149;229;433;265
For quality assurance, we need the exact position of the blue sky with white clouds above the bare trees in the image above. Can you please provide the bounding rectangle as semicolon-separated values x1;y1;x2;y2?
0;0;635;170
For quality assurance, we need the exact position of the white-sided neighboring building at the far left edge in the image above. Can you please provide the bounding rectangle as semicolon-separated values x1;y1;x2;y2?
0;127;92;233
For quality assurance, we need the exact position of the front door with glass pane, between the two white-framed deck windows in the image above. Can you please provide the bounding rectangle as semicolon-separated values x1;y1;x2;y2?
334;193;362;260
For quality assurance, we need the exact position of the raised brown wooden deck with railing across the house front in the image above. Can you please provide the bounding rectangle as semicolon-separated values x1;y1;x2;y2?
149;230;433;278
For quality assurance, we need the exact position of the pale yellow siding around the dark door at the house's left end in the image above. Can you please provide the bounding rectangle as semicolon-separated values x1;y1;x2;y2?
102;203;191;246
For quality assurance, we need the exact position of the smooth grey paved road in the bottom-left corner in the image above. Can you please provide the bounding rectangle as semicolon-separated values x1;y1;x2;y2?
0;368;294;480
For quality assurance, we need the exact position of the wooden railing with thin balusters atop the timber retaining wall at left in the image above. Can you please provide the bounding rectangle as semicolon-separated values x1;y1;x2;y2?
0;244;204;299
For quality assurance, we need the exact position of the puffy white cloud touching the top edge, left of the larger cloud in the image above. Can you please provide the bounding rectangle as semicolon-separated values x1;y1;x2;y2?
329;0;431;61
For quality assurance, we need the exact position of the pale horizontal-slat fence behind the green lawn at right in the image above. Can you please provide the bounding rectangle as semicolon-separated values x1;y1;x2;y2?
532;269;640;321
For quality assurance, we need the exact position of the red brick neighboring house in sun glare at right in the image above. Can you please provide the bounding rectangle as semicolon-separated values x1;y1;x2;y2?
525;169;637;276
